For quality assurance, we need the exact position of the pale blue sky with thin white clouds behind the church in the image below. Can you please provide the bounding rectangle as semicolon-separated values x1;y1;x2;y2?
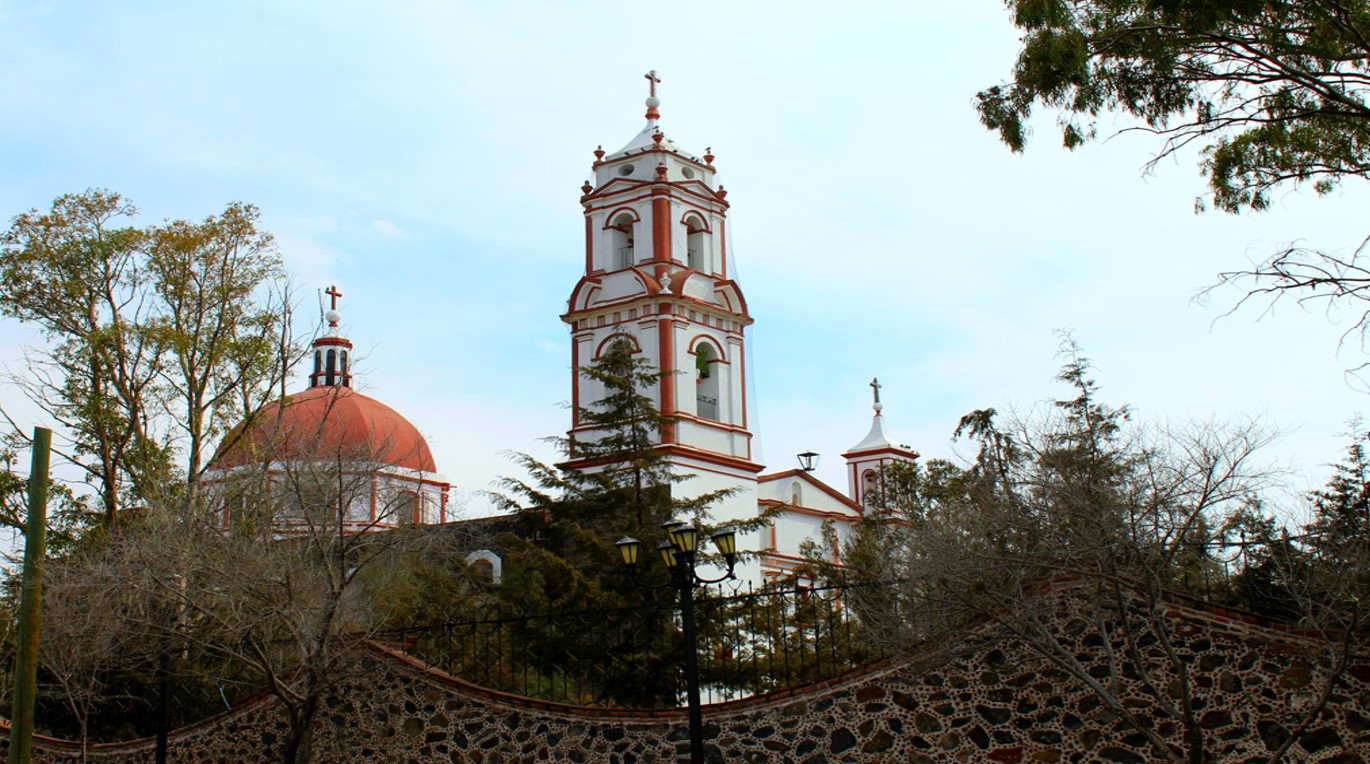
0;0;1370;515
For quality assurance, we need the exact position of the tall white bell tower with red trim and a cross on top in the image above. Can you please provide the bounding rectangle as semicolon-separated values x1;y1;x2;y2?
562;71;760;498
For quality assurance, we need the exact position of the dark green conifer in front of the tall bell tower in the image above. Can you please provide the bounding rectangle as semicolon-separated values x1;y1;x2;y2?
476;341;763;705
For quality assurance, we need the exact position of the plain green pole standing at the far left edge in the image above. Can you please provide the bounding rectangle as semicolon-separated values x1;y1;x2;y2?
10;427;52;764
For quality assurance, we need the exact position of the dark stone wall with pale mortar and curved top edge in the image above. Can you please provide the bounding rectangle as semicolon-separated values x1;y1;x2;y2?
10;598;1370;764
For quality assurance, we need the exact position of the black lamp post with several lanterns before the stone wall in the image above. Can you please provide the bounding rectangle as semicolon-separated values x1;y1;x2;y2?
615;520;737;764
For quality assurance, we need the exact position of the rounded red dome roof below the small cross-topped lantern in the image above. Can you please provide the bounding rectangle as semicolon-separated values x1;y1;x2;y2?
211;385;437;472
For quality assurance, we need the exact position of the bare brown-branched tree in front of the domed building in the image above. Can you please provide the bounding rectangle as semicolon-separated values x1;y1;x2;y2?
37;402;434;764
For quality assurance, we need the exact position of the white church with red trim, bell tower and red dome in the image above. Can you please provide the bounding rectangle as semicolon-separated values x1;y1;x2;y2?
202;71;918;582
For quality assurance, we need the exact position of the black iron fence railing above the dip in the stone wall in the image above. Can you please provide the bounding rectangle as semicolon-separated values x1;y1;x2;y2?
401;586;881;708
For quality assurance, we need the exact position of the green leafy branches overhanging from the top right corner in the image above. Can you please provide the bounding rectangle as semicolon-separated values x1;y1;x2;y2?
977;0;1370;212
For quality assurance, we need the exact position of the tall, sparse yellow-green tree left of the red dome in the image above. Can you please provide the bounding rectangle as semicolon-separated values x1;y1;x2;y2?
0;190;299;526
